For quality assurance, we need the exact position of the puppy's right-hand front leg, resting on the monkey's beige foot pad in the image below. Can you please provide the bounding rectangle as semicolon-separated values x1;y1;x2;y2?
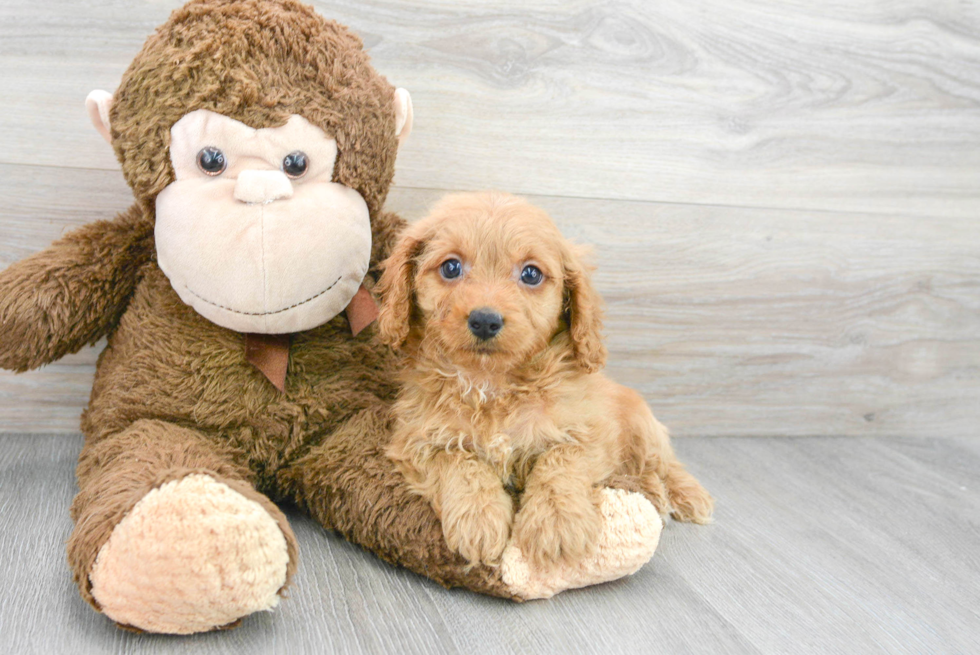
514;444;602;568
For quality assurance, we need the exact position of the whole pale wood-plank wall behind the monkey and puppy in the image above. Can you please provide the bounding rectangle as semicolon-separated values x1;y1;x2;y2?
0;0;980;436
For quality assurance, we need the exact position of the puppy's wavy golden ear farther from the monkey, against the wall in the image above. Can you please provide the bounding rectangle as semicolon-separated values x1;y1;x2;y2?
564;244;606;373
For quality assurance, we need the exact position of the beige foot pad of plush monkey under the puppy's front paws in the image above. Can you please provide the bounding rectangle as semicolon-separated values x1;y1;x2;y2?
500;489;663;600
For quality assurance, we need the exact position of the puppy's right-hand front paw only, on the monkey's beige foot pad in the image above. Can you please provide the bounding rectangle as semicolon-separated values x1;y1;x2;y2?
514;491;602;569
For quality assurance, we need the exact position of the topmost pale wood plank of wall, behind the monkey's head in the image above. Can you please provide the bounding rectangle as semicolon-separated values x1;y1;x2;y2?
0;0;980;218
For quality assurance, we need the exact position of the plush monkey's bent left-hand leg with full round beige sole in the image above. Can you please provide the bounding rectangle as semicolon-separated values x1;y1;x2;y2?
68;420;297;634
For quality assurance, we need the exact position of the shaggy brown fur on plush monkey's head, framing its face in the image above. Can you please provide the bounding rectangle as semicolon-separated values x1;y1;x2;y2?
110;0;397;216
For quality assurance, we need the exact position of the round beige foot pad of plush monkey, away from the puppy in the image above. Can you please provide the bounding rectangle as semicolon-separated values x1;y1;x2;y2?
89;474;289;634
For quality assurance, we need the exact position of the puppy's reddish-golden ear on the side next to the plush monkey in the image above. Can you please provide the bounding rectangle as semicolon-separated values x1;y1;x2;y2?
376;227;423;348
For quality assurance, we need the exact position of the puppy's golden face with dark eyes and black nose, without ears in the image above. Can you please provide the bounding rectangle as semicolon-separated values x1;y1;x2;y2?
414;200;564;368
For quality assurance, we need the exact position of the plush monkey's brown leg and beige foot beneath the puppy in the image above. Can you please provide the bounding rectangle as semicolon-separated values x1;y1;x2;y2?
280;403;663;600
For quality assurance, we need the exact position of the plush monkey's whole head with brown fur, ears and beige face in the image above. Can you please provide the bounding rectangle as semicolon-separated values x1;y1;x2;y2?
80;0;412;334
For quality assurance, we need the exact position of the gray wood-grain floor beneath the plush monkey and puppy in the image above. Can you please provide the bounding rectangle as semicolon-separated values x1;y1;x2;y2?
0;435;980;655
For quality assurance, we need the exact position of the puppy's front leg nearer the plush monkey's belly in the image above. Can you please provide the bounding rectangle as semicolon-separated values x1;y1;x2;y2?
430;452;514;564
